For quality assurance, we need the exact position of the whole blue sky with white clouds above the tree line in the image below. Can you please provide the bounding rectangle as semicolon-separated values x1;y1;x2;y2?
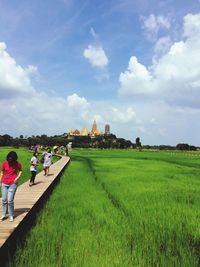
0;0;200;146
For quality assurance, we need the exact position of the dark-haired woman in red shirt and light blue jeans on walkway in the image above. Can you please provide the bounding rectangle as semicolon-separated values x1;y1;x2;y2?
0;151;22;222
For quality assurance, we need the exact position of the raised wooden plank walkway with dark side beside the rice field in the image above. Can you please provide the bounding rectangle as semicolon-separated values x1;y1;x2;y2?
0;156;70;262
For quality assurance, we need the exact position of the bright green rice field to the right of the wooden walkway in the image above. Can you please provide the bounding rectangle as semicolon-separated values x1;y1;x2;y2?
2;149;200;267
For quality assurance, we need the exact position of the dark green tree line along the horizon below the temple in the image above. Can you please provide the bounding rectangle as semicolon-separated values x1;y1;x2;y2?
0;134;198;151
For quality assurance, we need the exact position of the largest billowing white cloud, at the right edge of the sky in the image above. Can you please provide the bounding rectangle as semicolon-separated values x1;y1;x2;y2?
119;14;200;107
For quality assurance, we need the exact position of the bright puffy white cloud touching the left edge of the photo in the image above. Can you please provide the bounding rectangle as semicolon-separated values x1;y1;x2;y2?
0;42;36;98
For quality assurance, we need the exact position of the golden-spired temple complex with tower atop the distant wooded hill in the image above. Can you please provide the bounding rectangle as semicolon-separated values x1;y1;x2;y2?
67;120;110;137
